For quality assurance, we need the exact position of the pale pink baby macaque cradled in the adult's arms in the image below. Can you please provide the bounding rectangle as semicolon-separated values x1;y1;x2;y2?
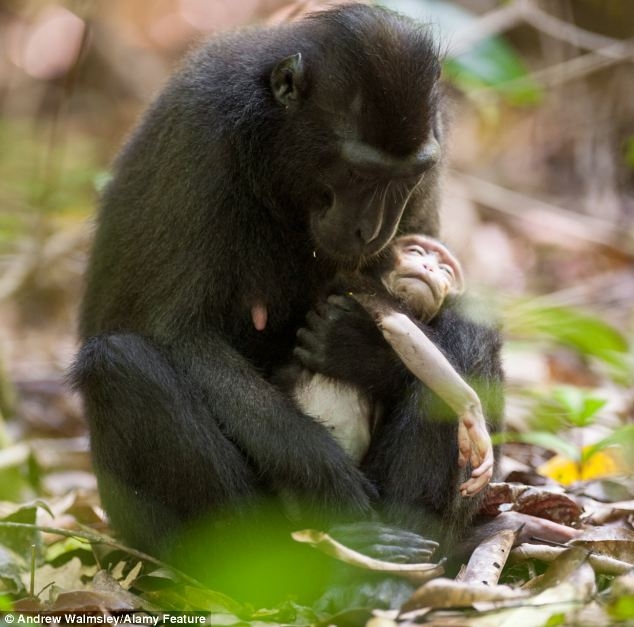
252;235;493;496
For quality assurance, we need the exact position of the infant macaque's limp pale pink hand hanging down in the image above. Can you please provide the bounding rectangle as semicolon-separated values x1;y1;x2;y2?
458;408;493;496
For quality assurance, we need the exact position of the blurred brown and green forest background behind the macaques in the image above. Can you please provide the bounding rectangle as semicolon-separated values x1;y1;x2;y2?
0;0;634;513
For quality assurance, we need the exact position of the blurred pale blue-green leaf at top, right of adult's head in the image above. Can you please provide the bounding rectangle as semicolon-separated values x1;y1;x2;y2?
378;0;542;105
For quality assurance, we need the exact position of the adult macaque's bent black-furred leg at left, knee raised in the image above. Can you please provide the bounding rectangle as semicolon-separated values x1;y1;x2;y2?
72;334;258;552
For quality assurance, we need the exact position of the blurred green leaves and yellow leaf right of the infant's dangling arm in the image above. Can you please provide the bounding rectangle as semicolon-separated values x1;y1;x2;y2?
497;298;634;483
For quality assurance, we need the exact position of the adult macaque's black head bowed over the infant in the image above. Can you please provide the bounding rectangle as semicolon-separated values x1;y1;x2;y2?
269;5;442;263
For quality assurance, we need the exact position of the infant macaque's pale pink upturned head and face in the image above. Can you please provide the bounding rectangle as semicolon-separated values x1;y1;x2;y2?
381;235;464;320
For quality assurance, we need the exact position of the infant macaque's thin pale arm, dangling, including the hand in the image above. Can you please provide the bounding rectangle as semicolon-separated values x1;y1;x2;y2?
355;295;493;496
